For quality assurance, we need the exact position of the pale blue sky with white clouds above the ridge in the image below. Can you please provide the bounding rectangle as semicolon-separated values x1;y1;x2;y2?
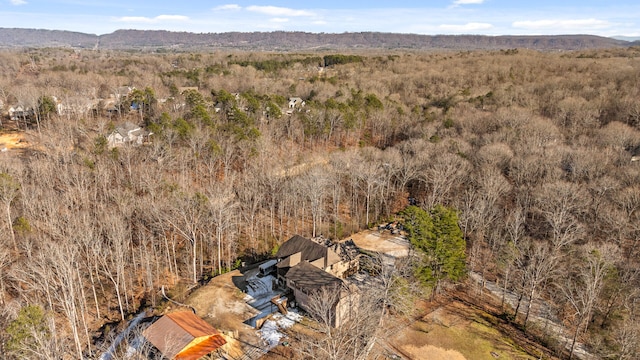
0;0;640;38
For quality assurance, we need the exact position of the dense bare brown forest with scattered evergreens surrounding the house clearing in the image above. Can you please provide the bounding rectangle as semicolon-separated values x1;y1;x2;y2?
0;48;640;359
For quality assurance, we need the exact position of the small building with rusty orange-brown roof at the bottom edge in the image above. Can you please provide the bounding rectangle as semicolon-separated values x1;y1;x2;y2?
142;311;227;360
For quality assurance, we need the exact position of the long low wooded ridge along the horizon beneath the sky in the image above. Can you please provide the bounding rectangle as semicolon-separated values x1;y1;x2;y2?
0;28;639;50
